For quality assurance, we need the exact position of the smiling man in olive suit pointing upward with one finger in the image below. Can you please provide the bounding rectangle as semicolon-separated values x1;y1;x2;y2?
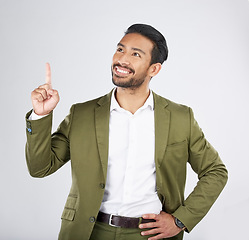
26;24;227;240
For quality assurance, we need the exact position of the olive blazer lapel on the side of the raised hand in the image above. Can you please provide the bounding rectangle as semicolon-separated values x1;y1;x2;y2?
95;92;112;180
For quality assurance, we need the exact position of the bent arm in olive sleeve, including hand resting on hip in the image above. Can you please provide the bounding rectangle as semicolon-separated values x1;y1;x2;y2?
140;109;227;240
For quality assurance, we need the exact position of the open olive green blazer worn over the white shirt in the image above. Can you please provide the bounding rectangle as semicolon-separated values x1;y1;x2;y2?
26;90;227;240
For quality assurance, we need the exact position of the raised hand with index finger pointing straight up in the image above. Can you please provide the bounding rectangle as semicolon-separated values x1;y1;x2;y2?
31;63;60;115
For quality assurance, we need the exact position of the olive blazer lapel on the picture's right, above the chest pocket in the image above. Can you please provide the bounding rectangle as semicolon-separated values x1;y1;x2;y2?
153;92;170;167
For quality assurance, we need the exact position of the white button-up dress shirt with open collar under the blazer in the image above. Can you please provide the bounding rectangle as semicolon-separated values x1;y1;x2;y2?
100;91;162;217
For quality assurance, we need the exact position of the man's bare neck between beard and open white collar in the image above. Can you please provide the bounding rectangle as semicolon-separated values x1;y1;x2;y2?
115;86;150;114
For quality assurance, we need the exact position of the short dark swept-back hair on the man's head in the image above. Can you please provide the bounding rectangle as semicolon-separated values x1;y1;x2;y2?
125;24;168;64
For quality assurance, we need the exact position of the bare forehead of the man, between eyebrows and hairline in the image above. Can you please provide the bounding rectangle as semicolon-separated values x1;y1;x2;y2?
120;33;154;53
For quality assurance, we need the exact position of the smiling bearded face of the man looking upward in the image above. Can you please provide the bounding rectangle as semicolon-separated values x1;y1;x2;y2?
112;33;153;89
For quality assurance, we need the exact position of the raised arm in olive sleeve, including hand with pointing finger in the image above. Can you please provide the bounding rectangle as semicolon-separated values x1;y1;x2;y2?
26;64;70;177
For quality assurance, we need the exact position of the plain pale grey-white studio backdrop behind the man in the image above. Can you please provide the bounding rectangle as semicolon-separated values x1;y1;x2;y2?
0;0;249;240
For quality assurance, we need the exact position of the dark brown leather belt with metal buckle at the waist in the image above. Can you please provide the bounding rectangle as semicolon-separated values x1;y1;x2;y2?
97;212;155;228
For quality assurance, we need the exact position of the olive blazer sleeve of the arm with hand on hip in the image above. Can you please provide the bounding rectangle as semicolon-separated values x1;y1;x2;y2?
173;108;228;232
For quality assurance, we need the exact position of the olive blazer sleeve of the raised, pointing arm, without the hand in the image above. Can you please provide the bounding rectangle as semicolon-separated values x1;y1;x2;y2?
25;106;74;178
